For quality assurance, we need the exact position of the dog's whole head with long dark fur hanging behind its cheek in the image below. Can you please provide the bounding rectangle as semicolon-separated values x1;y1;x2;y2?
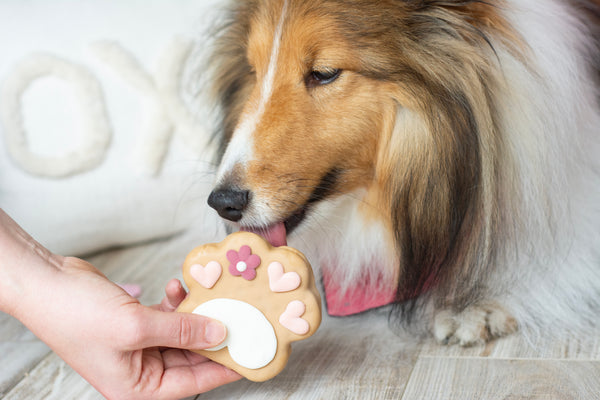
209;0;511;300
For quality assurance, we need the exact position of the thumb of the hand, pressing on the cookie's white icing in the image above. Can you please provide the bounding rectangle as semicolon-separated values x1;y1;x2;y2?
135;307;227;350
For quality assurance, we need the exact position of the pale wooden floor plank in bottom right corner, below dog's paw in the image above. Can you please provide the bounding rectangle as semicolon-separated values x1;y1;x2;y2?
402;357;600;400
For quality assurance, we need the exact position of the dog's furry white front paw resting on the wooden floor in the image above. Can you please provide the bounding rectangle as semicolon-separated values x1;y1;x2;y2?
433;303;517;347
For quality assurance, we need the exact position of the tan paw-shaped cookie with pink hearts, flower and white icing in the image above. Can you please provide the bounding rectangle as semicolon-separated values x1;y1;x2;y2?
177;232;321;381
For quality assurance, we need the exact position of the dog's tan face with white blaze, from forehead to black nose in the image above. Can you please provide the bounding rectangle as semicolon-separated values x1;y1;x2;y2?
211;1;395;239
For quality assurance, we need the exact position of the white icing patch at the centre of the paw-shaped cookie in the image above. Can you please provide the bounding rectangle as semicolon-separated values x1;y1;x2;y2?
193;299;277;369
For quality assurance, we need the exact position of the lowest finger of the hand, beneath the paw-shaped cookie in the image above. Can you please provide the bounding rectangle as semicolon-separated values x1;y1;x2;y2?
160;361;242;398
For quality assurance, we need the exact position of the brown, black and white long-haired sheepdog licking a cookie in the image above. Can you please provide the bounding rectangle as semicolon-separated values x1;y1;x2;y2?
203;0;600;345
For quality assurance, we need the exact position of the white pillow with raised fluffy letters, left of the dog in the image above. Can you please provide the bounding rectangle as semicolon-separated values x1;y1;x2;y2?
0;0;222;254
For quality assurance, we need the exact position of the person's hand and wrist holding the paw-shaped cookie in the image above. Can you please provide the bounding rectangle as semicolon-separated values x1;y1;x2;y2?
0;210;240;399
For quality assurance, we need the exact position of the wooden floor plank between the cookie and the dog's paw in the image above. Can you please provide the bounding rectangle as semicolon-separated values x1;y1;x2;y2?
200;312;418;400
